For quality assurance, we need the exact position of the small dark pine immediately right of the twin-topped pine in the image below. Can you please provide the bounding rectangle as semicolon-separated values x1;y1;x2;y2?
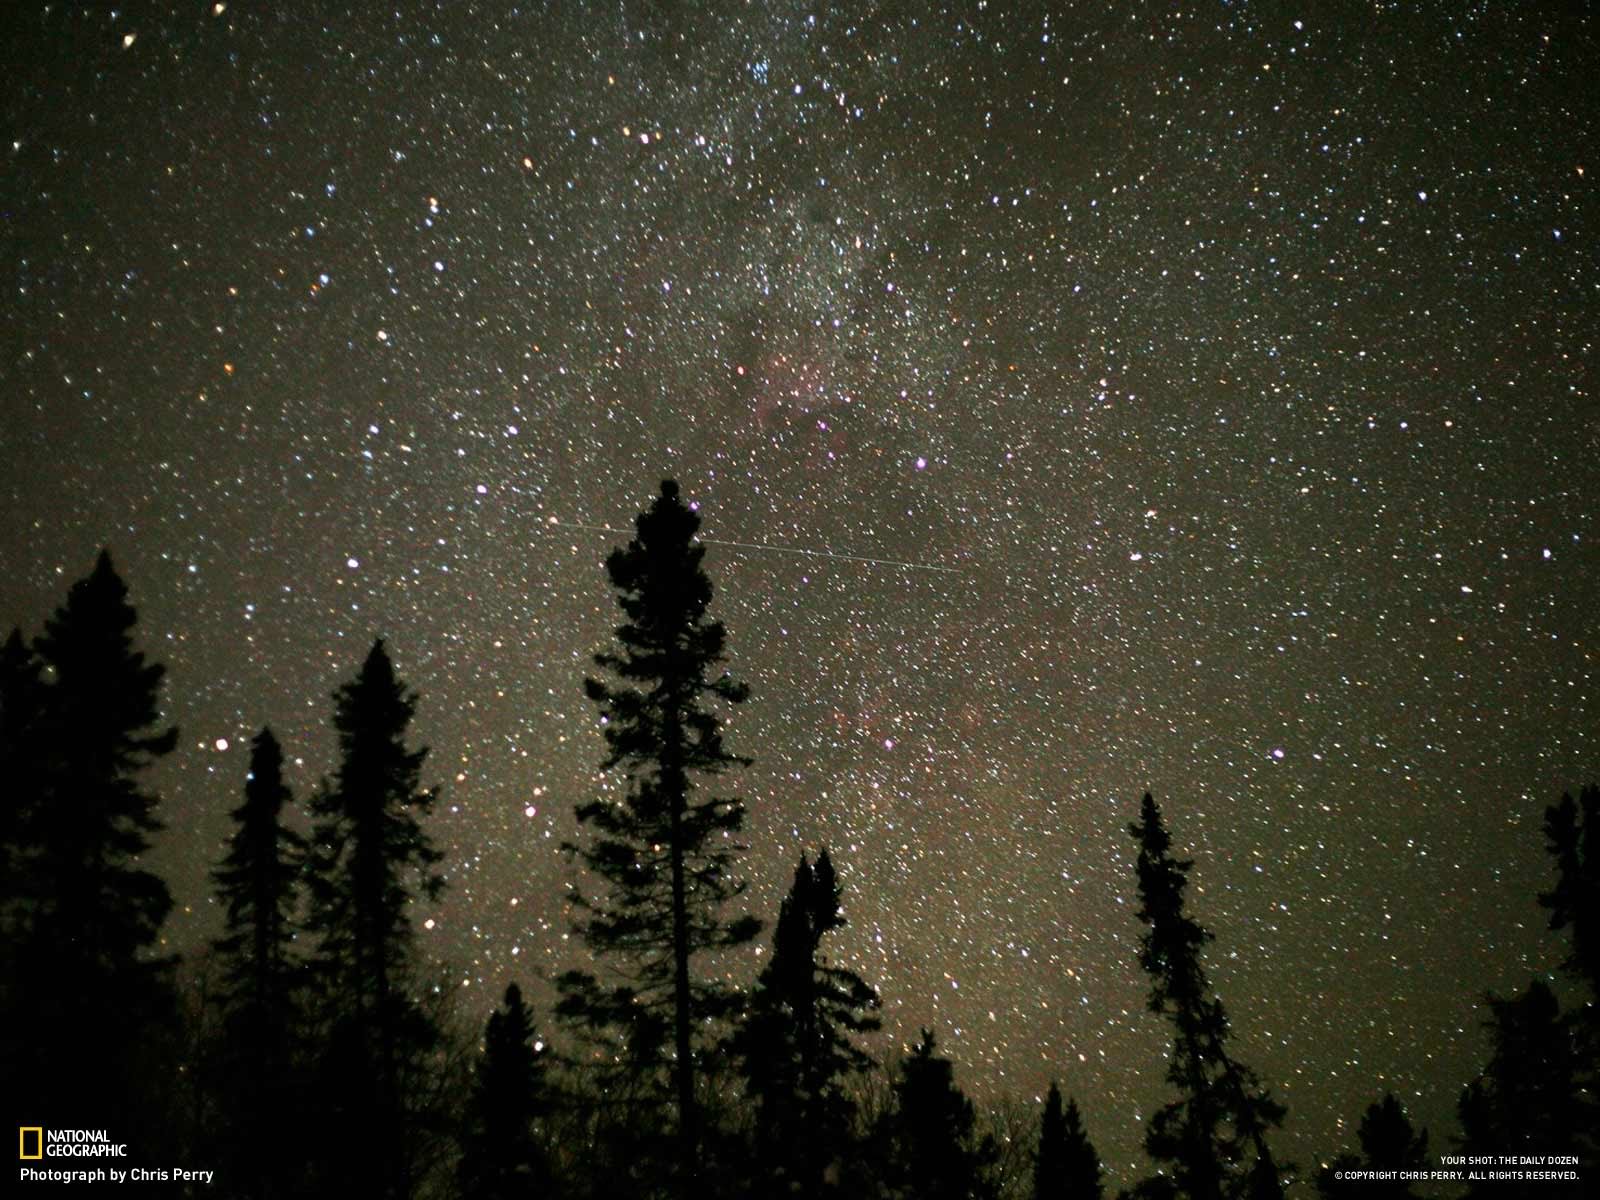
886;1029;998;1200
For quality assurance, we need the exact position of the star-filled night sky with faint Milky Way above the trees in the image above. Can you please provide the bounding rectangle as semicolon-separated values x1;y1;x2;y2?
0;0;1600;1184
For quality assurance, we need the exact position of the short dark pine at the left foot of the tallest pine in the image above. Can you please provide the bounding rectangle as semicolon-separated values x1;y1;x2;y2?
459;984;552;1200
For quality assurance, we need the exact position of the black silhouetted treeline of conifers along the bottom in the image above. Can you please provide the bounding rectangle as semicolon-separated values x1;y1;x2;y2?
0;482;1600;1200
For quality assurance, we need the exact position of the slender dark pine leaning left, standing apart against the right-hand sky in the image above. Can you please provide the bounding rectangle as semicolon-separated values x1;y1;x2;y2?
1130;794;1283;1200
